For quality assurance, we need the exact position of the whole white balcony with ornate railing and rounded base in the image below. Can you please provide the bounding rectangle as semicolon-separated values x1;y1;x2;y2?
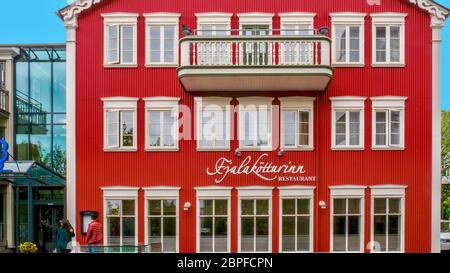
178;31;333;92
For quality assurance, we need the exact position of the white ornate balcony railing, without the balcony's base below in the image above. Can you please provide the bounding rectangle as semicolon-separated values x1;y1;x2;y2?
180;35;330;67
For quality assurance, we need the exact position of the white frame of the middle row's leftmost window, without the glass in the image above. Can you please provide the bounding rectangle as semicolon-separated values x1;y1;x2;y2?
101;97;139;152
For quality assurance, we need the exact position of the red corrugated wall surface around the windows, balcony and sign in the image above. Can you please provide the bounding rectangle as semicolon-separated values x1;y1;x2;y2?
76;0;431;252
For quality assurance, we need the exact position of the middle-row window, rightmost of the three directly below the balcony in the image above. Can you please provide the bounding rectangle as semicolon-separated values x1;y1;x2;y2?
279;97;315;150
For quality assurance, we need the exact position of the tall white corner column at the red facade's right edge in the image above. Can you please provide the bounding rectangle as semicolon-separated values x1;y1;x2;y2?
431;25;442;253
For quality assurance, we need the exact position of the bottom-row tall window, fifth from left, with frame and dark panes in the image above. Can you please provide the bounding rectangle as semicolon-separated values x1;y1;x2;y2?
278;186;315;252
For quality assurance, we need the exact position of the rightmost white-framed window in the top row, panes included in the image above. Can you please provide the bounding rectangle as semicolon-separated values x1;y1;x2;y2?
371;13;407;66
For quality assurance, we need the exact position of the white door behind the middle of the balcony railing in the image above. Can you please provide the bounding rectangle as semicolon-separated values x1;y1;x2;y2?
242;25;272;66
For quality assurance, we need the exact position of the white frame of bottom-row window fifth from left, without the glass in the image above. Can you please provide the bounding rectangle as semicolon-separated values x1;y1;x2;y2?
278;186;316;253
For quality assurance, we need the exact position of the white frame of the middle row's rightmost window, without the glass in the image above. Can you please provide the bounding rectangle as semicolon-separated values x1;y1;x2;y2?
370;96;408;150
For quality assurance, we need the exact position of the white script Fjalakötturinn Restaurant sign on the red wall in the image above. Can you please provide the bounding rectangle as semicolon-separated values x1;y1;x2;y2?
206;154;316;184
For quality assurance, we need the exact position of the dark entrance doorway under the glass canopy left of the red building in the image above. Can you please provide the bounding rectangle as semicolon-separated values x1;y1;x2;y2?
34;205;64;253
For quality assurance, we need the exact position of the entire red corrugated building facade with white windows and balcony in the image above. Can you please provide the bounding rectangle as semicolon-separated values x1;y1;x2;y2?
60;0;448;252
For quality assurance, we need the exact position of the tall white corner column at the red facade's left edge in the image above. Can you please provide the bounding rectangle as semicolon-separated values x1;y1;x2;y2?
66;25;77;237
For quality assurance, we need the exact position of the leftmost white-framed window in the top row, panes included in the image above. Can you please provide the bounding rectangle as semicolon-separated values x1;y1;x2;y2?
102;13;139;67
